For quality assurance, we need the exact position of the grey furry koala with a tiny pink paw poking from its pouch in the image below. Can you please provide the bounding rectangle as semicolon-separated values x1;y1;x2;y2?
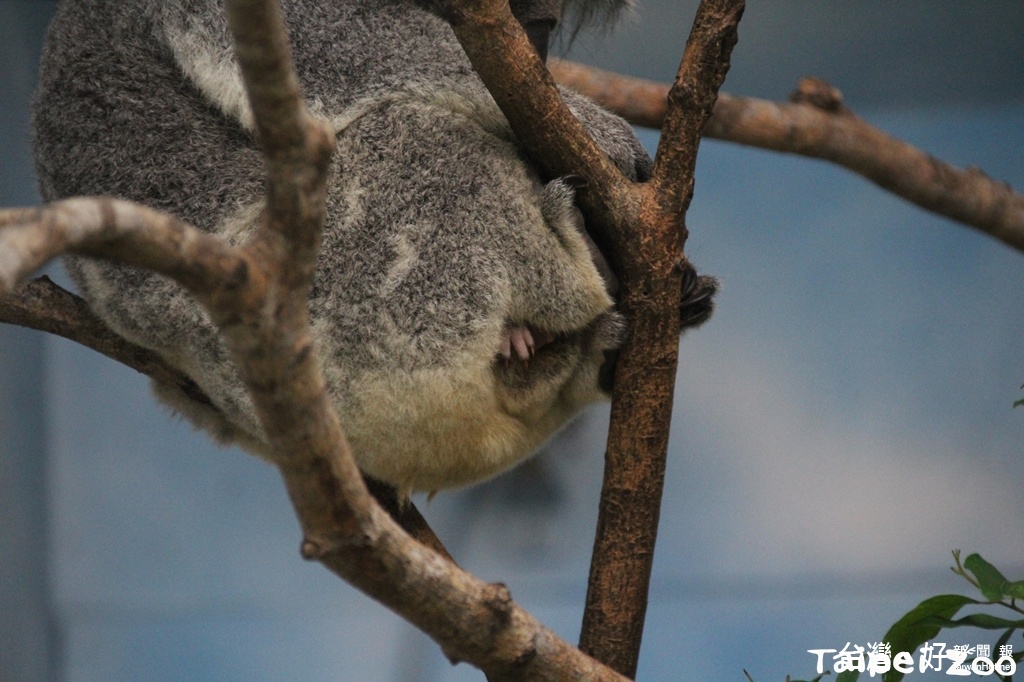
33;0;714;498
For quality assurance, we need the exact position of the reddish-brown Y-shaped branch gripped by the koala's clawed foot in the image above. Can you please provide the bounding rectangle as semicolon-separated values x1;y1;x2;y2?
442;0;742;675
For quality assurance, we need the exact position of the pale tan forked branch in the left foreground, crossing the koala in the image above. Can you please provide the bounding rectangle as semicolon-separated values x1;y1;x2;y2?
0;0;638;680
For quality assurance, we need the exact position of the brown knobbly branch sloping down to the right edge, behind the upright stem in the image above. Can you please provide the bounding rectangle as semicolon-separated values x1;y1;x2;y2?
549;59;1024;251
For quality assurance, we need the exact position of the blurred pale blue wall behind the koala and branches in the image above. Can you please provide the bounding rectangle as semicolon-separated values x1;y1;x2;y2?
0;0;1024;682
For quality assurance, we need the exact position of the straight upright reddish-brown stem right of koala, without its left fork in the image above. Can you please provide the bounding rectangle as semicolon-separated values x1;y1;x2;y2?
580;0;743;677
